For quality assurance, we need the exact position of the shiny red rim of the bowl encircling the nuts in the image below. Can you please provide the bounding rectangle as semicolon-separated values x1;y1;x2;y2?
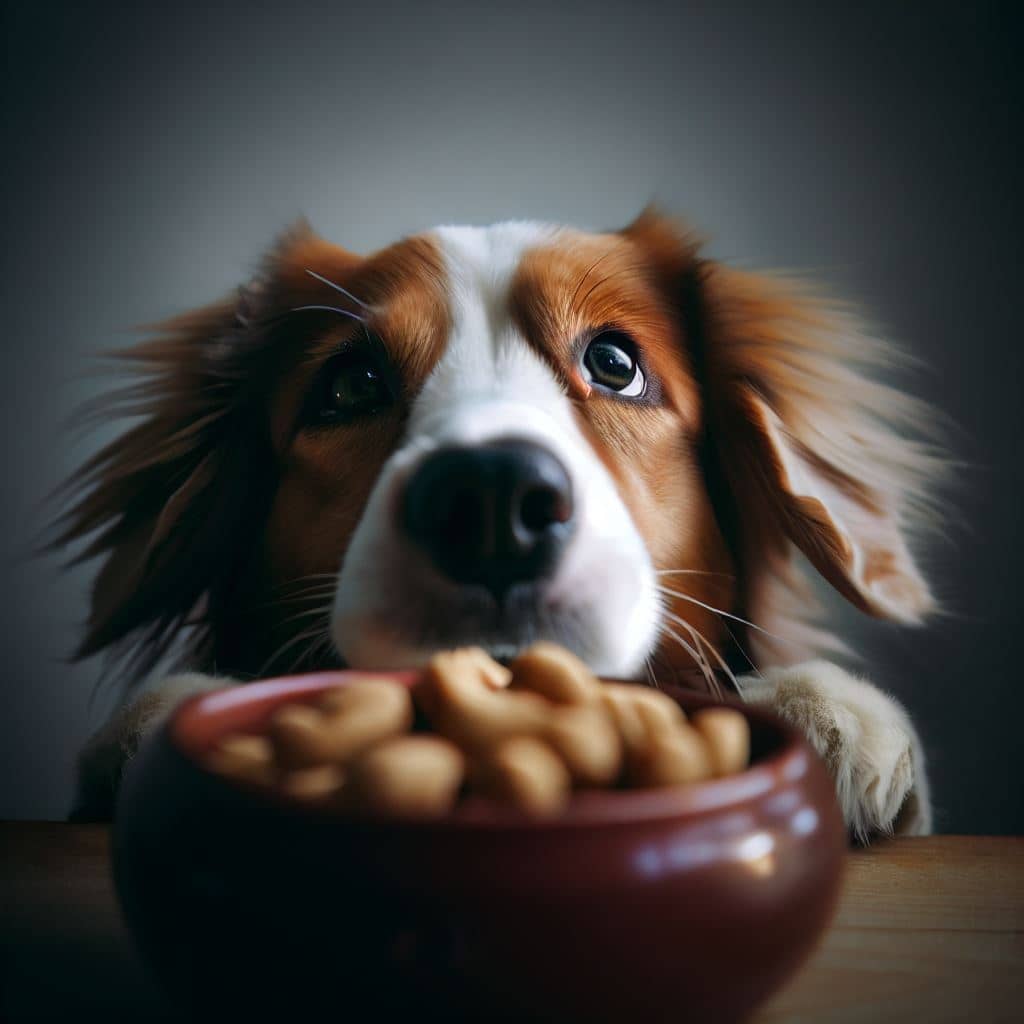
172;670;818;831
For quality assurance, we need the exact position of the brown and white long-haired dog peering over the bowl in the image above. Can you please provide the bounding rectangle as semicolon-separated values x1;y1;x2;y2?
57;209;942;840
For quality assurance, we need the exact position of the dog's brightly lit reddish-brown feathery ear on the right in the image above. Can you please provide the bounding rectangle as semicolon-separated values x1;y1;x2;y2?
686;261;943;624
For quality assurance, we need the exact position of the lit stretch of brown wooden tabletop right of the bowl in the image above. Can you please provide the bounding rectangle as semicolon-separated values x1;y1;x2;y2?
757;836;1024;1024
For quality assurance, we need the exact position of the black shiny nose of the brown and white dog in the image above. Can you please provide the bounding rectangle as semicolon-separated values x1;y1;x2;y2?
402;439;572;598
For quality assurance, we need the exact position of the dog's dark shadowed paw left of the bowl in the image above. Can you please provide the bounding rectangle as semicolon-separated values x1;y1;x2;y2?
70;672;234;821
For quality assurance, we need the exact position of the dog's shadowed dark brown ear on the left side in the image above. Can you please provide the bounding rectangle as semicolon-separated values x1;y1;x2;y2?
50;223;356;672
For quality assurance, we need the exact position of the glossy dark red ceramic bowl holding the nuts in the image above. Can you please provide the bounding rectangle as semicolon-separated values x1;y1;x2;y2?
114;673;846;1022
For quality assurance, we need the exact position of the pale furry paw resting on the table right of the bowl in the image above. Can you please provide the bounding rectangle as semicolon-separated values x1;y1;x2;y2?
740;662;932;842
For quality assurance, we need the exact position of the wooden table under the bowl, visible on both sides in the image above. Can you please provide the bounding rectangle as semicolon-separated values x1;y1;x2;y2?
0;822;1024;1024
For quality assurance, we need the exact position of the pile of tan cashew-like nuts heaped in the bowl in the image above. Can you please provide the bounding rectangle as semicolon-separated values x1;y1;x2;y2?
208;643;750;818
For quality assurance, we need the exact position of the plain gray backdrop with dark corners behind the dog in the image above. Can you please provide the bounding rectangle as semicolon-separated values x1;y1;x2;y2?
0;2;1024;833
